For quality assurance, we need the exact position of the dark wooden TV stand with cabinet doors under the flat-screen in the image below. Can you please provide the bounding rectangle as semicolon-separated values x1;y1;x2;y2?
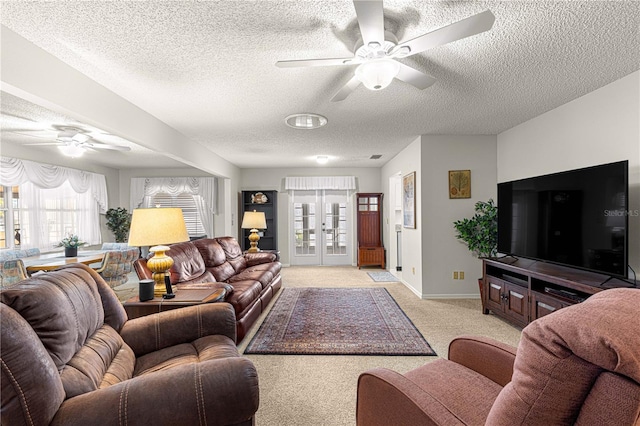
481;257;633;327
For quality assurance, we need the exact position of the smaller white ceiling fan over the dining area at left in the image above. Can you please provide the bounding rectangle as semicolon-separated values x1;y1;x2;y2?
5;125;131;158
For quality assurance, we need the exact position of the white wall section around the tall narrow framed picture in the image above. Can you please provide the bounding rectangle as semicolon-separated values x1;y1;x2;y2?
380;137;423;297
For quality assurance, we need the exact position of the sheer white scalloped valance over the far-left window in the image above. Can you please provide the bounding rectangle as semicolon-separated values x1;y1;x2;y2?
0;157;109;214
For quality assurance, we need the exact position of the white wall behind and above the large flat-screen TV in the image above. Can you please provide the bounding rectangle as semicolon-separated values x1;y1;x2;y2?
498;71;640;273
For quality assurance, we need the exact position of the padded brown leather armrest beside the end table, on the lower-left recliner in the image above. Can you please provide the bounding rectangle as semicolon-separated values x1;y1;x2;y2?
120;303;236;357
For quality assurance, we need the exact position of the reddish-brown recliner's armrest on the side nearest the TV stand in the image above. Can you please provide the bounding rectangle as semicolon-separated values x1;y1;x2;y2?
449;336;516;386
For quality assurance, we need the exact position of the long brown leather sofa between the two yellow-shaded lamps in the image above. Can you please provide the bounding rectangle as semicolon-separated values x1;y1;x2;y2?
134;237;282;342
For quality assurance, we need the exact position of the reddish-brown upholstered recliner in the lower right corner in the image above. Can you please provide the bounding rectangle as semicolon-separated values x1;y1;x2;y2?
356;289;640;426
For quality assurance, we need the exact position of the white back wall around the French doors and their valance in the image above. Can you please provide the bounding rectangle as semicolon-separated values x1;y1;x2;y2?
236;167;383;265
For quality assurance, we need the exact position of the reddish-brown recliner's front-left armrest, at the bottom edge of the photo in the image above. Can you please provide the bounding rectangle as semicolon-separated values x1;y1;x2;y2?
356;368;462;426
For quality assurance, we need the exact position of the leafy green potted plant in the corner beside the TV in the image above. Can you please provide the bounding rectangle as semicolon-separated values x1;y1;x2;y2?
453;199;498;312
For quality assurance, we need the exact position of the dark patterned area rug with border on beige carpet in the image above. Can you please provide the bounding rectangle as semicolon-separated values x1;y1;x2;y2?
244;287;436;355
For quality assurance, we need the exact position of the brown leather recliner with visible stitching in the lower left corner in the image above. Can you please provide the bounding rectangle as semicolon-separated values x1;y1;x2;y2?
0;264;259;426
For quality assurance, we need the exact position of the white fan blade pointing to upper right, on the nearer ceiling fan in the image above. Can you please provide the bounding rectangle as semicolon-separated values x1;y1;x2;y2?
394;10;496;56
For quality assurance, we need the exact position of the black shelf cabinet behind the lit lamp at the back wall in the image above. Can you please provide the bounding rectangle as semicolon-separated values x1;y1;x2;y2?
238;190;278;250
